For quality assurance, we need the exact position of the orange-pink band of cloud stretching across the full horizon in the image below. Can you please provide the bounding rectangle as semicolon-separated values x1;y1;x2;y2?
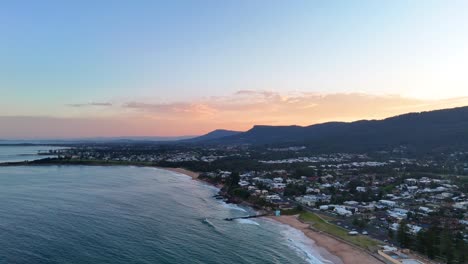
0;90;468;138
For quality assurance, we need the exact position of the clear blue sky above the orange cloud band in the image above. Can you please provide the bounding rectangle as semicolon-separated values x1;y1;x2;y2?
0;0;468;138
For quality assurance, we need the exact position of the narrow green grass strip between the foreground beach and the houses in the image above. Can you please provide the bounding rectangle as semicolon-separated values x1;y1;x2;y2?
299;212;379;251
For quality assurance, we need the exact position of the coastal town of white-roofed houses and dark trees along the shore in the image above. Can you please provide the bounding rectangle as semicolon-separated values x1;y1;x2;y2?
18;144;468;263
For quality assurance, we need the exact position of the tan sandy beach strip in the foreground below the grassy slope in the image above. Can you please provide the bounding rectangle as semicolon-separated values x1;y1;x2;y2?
269;215;383;264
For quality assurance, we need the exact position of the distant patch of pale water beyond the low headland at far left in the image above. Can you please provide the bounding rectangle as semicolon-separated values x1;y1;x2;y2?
0;146;66;162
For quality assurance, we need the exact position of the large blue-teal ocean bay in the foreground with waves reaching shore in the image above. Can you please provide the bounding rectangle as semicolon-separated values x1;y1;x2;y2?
0;166;336;264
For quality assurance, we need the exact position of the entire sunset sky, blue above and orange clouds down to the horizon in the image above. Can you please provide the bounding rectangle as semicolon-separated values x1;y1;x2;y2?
0;0;468;139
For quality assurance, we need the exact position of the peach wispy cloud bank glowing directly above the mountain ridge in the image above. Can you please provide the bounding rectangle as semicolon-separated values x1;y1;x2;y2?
123;90;468;127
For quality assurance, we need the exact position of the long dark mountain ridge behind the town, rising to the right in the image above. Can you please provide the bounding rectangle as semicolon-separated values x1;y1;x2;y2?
198;107;468;151
